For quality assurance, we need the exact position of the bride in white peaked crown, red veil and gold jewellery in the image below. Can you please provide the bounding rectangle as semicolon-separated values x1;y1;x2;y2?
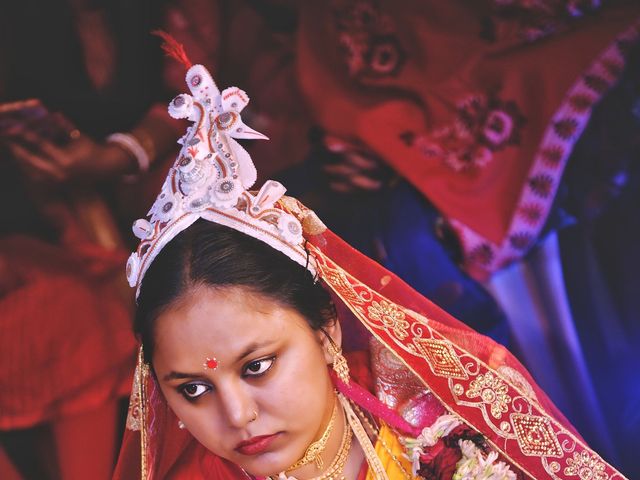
116;39;624;480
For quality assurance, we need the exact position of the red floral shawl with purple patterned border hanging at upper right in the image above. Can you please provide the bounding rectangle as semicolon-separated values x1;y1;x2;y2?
297;0;640;281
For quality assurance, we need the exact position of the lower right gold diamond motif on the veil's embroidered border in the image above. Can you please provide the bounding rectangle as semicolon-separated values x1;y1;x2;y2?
510;413;564;457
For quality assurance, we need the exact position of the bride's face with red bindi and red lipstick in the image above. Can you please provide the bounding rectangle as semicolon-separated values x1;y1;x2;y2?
153;287;339;476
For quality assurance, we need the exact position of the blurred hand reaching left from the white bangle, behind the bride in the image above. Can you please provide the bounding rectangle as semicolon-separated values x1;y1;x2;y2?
5;130;137;183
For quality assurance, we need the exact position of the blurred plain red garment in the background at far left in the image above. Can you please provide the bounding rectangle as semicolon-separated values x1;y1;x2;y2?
0;216;136;430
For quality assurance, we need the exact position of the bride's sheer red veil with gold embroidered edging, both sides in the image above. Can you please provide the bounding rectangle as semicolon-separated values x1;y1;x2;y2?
115;197;624;480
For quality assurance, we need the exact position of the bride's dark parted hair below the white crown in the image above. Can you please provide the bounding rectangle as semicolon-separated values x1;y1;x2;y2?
134;219;336;362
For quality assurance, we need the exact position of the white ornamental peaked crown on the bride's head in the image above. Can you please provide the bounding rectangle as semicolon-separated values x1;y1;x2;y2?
127;65;314;295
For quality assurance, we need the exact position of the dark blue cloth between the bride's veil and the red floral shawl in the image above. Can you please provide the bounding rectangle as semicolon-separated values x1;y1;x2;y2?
279;158;510;346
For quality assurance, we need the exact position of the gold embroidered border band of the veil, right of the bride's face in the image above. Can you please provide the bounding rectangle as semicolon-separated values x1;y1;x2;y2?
310;245;625;480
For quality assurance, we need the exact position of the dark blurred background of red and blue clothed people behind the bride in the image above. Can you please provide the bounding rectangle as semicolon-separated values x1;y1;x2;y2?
0;0;640;480
